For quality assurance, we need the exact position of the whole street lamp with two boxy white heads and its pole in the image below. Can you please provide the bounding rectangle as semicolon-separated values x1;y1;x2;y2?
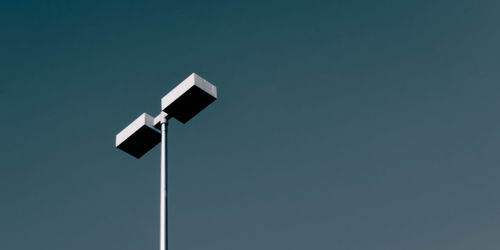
115;73;217;250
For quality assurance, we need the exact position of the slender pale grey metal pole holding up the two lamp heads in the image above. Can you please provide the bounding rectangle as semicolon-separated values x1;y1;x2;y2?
160;117;168;250
